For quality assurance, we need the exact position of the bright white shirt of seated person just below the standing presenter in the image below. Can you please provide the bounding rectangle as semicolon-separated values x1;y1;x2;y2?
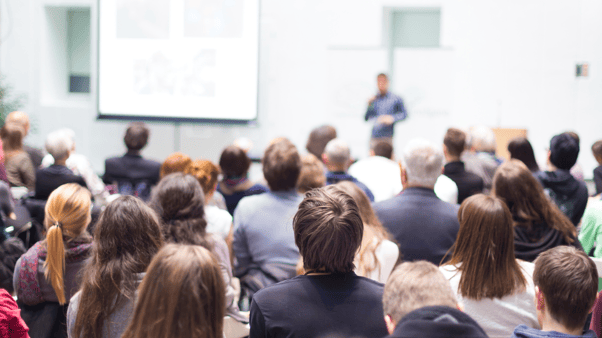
348;156;402;202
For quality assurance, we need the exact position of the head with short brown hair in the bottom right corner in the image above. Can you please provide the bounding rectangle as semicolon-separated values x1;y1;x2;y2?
533;245;598;330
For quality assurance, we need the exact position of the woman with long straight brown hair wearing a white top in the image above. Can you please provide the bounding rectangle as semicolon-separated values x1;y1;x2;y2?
439;194;540;338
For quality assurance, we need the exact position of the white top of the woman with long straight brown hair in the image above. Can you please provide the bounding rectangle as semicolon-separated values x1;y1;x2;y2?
439;260;541;338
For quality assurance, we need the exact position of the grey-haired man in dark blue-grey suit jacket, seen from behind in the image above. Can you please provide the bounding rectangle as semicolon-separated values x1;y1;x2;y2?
374;140;460;265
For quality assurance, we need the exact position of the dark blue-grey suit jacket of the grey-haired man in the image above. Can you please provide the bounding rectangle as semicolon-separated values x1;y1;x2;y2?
374;187;460;266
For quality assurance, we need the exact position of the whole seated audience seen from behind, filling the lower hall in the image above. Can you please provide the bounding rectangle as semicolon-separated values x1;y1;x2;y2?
0;112;602;338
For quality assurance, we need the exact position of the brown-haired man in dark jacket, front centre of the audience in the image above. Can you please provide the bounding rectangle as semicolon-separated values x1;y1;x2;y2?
250;186;387;338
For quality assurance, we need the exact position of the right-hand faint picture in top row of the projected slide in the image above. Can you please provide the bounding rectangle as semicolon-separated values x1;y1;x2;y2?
184;0;244;38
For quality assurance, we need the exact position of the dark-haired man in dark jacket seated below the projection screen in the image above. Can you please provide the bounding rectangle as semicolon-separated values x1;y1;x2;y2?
102;122;161;200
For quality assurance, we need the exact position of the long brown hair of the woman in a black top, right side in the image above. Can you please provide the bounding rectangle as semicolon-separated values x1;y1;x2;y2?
492;160;577;243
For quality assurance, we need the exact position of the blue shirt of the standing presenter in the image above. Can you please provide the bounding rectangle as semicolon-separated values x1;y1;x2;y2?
364;92;408;138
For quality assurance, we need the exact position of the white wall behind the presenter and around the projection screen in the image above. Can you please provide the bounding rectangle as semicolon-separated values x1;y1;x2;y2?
0;0;602;177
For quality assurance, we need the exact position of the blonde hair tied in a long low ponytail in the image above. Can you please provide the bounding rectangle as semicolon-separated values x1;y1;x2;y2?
44;183;92;304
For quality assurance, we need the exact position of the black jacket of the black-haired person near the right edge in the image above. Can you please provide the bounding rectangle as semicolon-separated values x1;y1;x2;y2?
536;169;589;225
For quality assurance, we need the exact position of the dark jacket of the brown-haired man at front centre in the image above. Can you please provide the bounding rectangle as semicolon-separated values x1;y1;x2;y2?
249;272;387;338
